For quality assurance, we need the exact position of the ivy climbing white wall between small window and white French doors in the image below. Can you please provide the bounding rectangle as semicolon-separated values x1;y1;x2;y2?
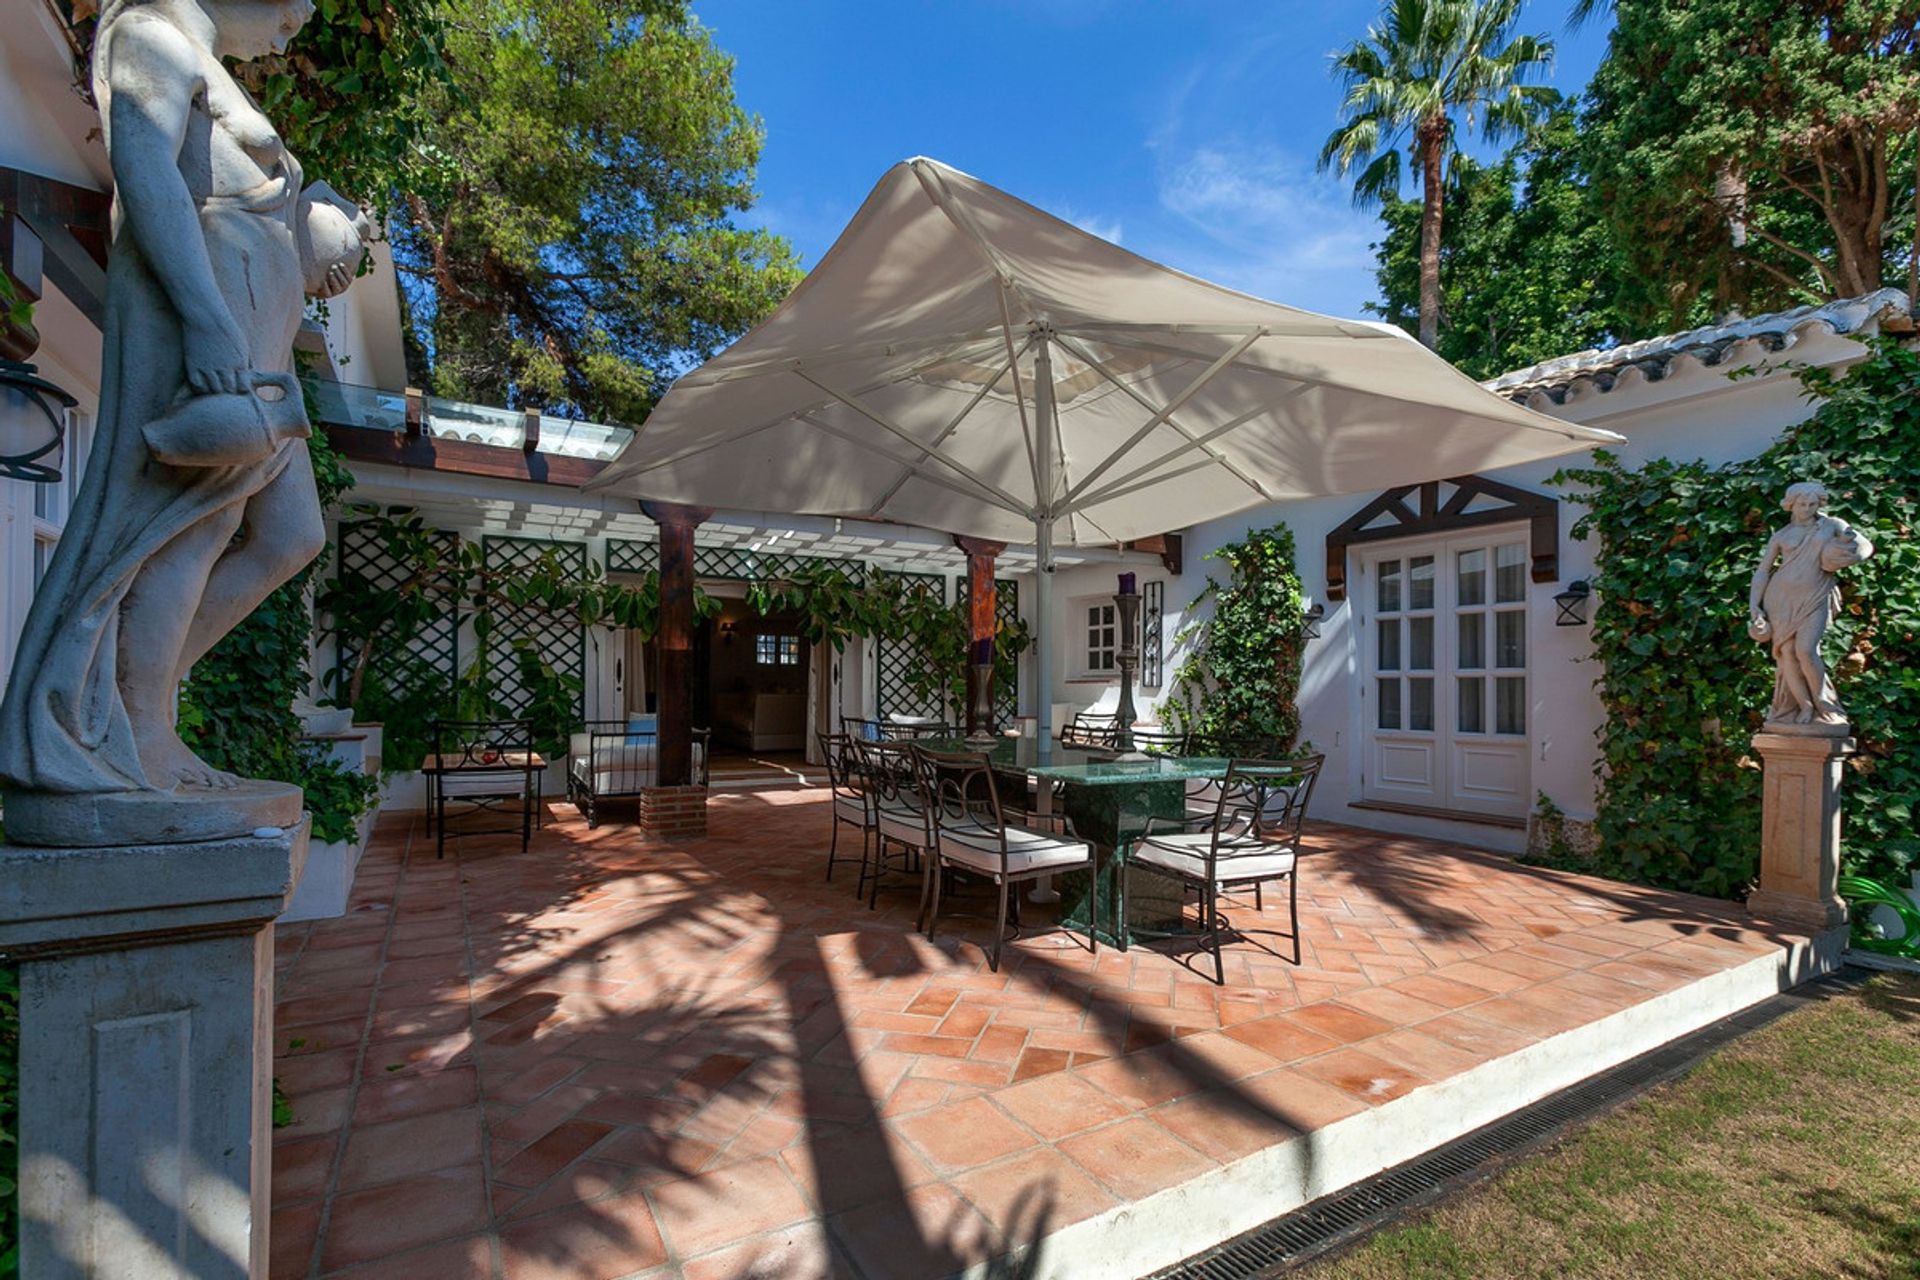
1165;524;1306;754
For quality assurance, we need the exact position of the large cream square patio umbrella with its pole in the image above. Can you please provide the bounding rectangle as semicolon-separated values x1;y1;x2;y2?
588;159;1620;737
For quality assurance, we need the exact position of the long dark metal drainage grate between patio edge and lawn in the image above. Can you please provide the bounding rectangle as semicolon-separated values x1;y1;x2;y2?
1152;969;1872;1280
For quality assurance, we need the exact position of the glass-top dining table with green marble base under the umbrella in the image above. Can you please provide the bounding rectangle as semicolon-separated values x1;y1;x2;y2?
924;737;1227;944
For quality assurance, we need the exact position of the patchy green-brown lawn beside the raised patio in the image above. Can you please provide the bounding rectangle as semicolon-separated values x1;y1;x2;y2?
1302;975;1920;1280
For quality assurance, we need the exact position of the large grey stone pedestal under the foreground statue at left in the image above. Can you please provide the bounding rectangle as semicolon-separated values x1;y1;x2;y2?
0;821;307;1280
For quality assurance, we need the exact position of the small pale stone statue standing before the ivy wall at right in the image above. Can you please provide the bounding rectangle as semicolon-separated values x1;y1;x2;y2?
1747;482;1874;735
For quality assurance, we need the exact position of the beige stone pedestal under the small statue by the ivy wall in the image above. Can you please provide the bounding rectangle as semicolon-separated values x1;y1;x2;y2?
1747;729;1855;931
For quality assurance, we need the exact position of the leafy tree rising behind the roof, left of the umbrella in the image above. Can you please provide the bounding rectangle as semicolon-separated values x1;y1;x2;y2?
392;0;801;422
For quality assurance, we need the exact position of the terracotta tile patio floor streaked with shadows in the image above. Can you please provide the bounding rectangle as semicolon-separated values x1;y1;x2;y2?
273;789;1778;1280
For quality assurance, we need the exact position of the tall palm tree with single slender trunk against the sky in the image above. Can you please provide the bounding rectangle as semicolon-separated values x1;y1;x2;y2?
1319;0;1553;347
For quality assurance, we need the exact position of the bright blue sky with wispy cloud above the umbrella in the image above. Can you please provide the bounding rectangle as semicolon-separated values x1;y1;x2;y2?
697;0;1605;315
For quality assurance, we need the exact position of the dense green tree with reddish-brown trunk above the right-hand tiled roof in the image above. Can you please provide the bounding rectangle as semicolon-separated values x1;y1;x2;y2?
1584;0;1920;328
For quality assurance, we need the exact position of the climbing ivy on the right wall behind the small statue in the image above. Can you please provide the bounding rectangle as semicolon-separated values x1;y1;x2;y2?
1555;338;1920;896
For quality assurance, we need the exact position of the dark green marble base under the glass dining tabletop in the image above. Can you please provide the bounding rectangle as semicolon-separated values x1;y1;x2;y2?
1054;781;1192;946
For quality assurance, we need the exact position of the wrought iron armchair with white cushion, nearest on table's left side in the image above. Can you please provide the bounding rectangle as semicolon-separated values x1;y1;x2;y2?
914;747;1100;973
